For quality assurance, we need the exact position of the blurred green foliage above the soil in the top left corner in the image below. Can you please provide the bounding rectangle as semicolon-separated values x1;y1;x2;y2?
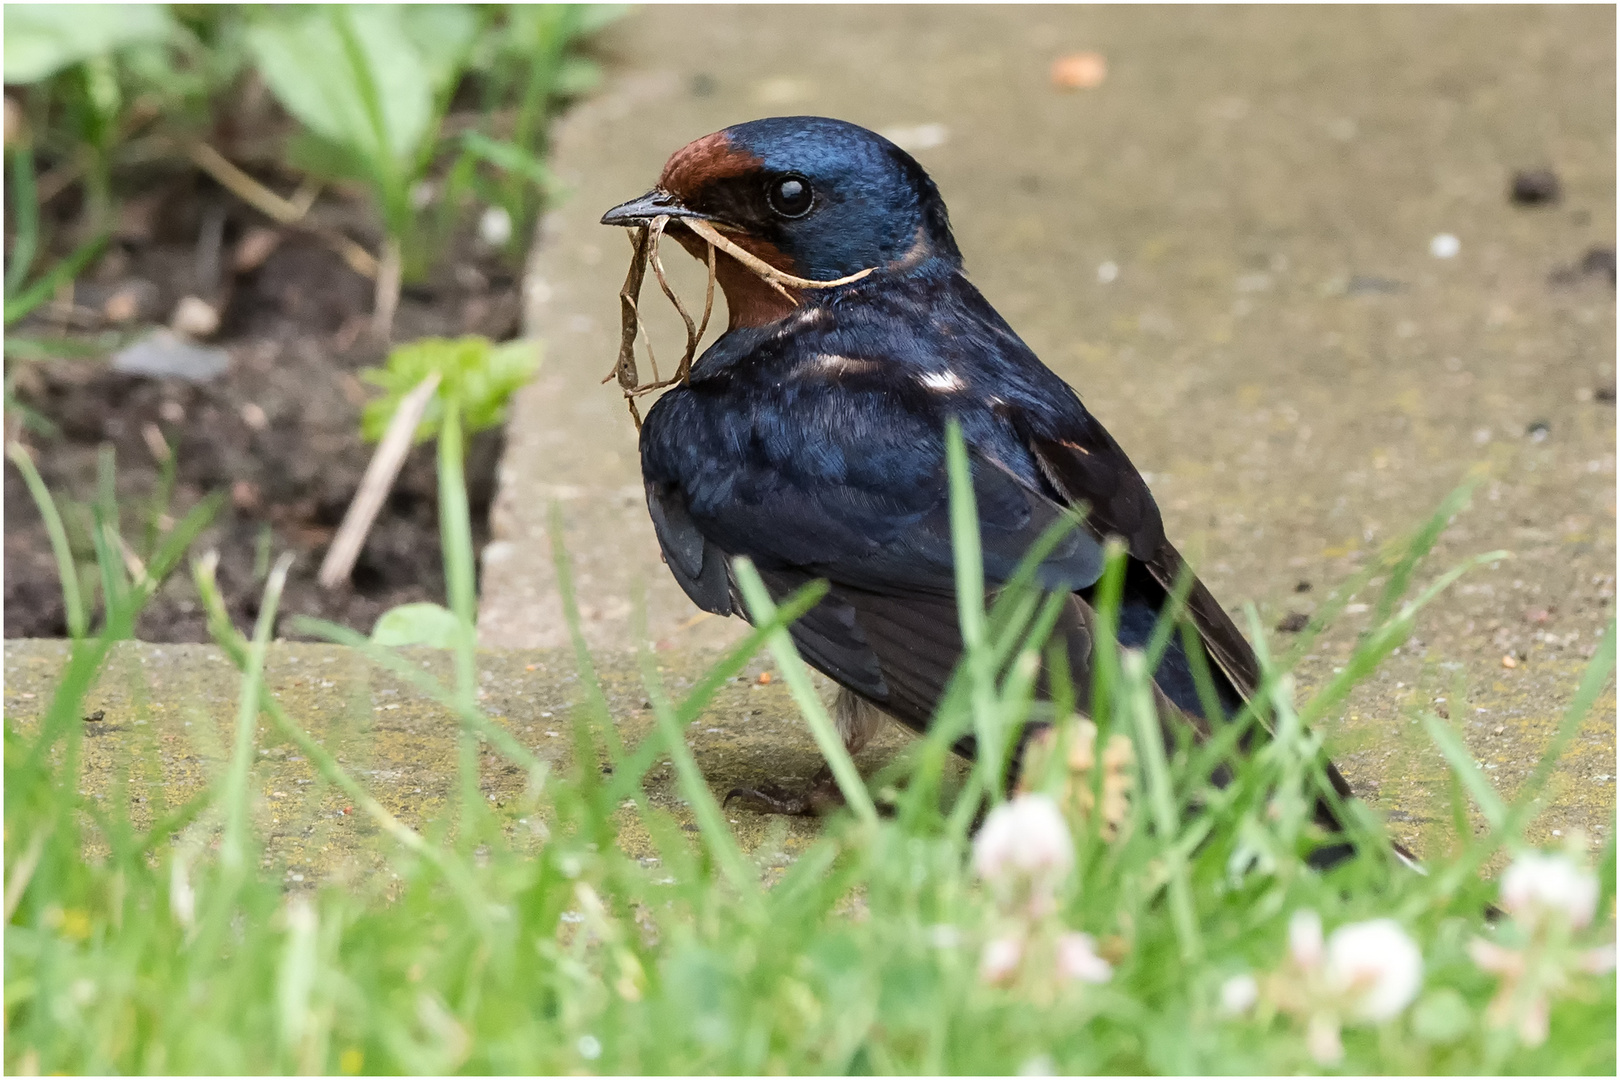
5;3;624;306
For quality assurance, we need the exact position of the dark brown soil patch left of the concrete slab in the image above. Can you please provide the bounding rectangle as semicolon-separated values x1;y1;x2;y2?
5;173;518;641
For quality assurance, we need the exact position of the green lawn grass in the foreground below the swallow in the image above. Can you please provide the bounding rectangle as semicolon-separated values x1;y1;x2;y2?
3;427;1615;1075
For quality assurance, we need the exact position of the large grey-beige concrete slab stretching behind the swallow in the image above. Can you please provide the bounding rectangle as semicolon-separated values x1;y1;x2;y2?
480;6;1615;844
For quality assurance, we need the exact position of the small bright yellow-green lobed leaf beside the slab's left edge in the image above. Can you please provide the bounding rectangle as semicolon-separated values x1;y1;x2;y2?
360;335;539;442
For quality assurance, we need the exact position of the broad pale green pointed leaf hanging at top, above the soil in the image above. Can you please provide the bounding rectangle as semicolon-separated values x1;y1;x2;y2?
248;5;439;175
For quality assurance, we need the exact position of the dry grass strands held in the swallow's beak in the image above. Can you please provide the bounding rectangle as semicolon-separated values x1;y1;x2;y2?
603;214;875;431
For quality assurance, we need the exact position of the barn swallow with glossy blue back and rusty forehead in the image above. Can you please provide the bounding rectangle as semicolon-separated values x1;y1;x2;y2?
603;117;1349;848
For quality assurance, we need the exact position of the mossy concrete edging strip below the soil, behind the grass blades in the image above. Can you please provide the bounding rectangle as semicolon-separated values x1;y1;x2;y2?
5;640;1614;887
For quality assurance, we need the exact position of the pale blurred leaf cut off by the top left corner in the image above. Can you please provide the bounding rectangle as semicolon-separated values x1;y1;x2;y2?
5;3;175;86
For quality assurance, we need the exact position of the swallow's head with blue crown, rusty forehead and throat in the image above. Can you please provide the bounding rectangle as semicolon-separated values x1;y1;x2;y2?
603;117;961;327
